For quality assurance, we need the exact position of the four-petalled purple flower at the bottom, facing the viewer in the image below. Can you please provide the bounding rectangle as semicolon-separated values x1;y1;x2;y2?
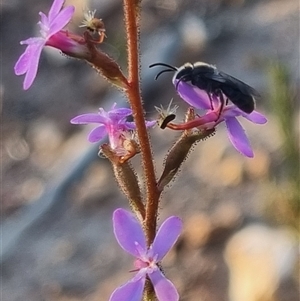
109;209;182;301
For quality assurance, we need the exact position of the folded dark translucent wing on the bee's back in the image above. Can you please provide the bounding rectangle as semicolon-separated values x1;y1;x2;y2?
209;71;260;97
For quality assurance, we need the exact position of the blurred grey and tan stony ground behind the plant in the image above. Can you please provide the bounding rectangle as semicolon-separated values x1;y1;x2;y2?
0;0;299;301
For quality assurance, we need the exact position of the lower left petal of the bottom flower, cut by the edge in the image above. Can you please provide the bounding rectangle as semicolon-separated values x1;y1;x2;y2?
109;277;145;301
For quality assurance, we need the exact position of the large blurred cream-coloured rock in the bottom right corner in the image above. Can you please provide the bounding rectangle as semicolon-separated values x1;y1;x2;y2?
225;224;296;301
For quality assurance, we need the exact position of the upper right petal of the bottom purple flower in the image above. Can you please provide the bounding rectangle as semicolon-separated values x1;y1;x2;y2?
152;216;182;261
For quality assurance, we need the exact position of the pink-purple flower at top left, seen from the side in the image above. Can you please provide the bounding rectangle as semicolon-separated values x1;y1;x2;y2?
15;0;75;90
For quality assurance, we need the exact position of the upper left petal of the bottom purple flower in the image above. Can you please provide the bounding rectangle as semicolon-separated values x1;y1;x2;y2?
113;208;146;258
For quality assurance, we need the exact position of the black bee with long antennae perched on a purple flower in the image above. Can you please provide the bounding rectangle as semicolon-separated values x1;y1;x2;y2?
149;62;260;114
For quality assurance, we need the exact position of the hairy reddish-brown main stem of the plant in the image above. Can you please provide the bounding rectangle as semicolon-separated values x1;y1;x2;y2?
124;0;160;245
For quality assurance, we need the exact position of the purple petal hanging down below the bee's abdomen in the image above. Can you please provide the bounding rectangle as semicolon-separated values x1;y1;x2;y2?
225;117;254;158
